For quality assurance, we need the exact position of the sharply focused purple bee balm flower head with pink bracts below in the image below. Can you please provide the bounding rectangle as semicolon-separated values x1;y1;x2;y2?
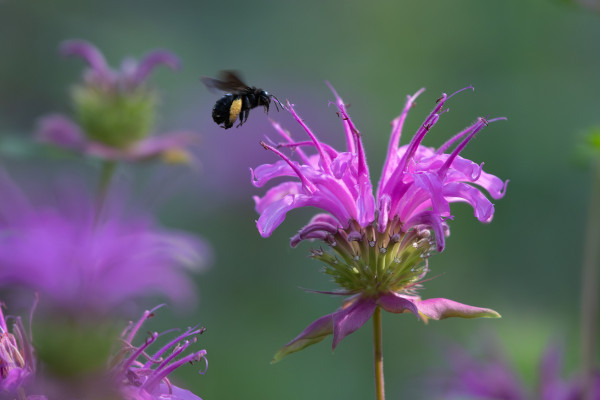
251;83;507;361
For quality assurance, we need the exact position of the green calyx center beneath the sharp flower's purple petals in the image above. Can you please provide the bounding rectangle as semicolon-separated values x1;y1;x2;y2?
311;220;435;295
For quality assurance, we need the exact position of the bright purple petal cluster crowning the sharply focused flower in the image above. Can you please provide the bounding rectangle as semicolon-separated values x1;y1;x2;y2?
252;89;508;251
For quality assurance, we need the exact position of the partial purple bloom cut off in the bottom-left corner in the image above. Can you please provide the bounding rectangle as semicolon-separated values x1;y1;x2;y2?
0;298;46;400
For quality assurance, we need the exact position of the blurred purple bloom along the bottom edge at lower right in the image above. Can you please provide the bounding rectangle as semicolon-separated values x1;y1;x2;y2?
434;340;600;400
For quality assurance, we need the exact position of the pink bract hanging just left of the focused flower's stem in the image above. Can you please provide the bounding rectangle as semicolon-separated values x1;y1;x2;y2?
332;297;377;350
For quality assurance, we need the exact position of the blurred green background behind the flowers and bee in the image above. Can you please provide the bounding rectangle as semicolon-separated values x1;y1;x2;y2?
0;0;600;400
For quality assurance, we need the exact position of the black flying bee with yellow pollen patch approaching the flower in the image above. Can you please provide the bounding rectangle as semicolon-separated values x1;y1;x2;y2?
202;71;279;129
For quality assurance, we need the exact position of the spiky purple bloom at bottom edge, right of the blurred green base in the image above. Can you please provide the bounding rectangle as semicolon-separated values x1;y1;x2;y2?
111;307;208;400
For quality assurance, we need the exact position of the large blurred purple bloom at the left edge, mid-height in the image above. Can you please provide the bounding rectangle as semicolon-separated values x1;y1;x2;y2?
0;174;209;314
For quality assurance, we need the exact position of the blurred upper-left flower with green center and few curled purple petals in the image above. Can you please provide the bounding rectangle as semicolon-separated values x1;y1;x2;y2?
36;40;197;162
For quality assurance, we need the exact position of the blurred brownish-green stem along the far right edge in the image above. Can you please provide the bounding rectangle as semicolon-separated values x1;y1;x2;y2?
581;160;600;400
